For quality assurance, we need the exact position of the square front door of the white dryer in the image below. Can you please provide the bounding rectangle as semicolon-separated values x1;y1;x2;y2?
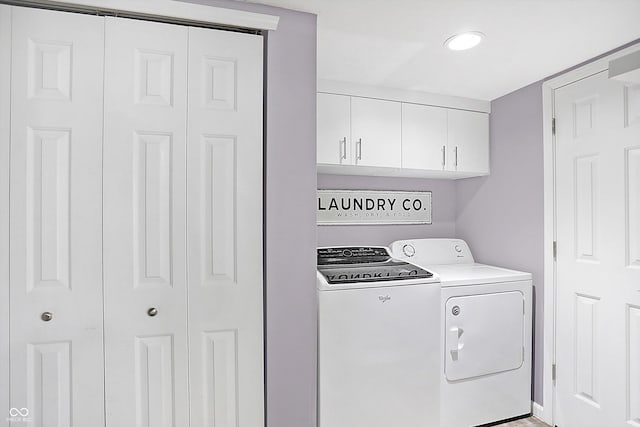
445;291;524;381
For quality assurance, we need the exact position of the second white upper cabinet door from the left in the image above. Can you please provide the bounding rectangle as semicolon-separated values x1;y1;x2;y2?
351;97;402;168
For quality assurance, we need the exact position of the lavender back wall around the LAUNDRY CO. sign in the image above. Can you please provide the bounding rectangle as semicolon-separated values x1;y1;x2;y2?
318;175;456;246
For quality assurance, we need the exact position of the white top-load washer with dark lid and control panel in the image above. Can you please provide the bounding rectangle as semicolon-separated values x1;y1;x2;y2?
317;247;440;427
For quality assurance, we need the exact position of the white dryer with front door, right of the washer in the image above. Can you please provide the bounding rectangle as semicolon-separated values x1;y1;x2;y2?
391;239;532;427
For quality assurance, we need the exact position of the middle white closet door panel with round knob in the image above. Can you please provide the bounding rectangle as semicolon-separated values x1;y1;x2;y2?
104;18;189;427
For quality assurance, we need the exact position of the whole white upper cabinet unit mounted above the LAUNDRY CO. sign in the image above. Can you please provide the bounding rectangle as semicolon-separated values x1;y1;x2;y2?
317;84;489;179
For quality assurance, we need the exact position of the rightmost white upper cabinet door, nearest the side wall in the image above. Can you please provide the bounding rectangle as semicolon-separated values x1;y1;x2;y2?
447;110;489;175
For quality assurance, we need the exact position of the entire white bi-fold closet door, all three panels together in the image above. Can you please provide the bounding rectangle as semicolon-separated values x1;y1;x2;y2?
0;6;264;427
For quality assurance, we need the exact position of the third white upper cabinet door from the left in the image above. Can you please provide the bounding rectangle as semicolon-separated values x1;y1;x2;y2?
402;104;447;170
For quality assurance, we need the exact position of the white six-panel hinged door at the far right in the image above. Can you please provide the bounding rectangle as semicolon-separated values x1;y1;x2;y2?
555;68;640;427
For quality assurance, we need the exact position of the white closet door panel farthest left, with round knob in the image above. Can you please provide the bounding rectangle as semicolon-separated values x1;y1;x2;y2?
8;7;104;427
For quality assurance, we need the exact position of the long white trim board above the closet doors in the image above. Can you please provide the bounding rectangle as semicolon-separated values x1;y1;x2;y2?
0;0;280;30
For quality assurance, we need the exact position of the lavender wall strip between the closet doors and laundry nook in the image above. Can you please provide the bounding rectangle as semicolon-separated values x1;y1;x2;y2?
179;0;317;427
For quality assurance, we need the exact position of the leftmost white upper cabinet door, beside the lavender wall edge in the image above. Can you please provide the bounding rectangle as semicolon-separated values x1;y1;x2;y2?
317;93;353;165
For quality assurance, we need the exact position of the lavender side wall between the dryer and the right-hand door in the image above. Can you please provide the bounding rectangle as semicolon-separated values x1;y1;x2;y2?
456;82;544;404
